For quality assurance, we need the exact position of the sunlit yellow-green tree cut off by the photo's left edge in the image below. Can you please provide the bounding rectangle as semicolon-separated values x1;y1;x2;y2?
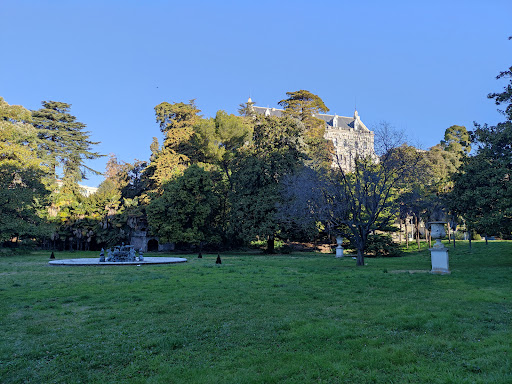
0;97;50;241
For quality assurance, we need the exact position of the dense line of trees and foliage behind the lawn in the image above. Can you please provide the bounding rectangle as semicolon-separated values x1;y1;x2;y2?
0;54;512;265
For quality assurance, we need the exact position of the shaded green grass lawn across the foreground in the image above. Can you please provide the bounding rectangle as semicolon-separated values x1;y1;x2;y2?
0;241;512;383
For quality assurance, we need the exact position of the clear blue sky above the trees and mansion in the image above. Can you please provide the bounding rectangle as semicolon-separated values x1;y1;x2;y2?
0;0;512;186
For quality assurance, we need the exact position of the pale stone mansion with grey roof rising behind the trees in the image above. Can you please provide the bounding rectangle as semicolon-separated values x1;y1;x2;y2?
249;99;375;172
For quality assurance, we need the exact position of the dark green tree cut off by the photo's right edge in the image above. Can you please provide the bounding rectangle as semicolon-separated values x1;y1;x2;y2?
449;55;512;235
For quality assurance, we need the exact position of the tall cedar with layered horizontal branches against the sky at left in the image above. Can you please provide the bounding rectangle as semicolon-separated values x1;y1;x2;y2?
32;101;102;184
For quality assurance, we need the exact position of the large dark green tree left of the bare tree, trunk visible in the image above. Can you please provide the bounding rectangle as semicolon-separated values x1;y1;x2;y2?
231;116;305;252
